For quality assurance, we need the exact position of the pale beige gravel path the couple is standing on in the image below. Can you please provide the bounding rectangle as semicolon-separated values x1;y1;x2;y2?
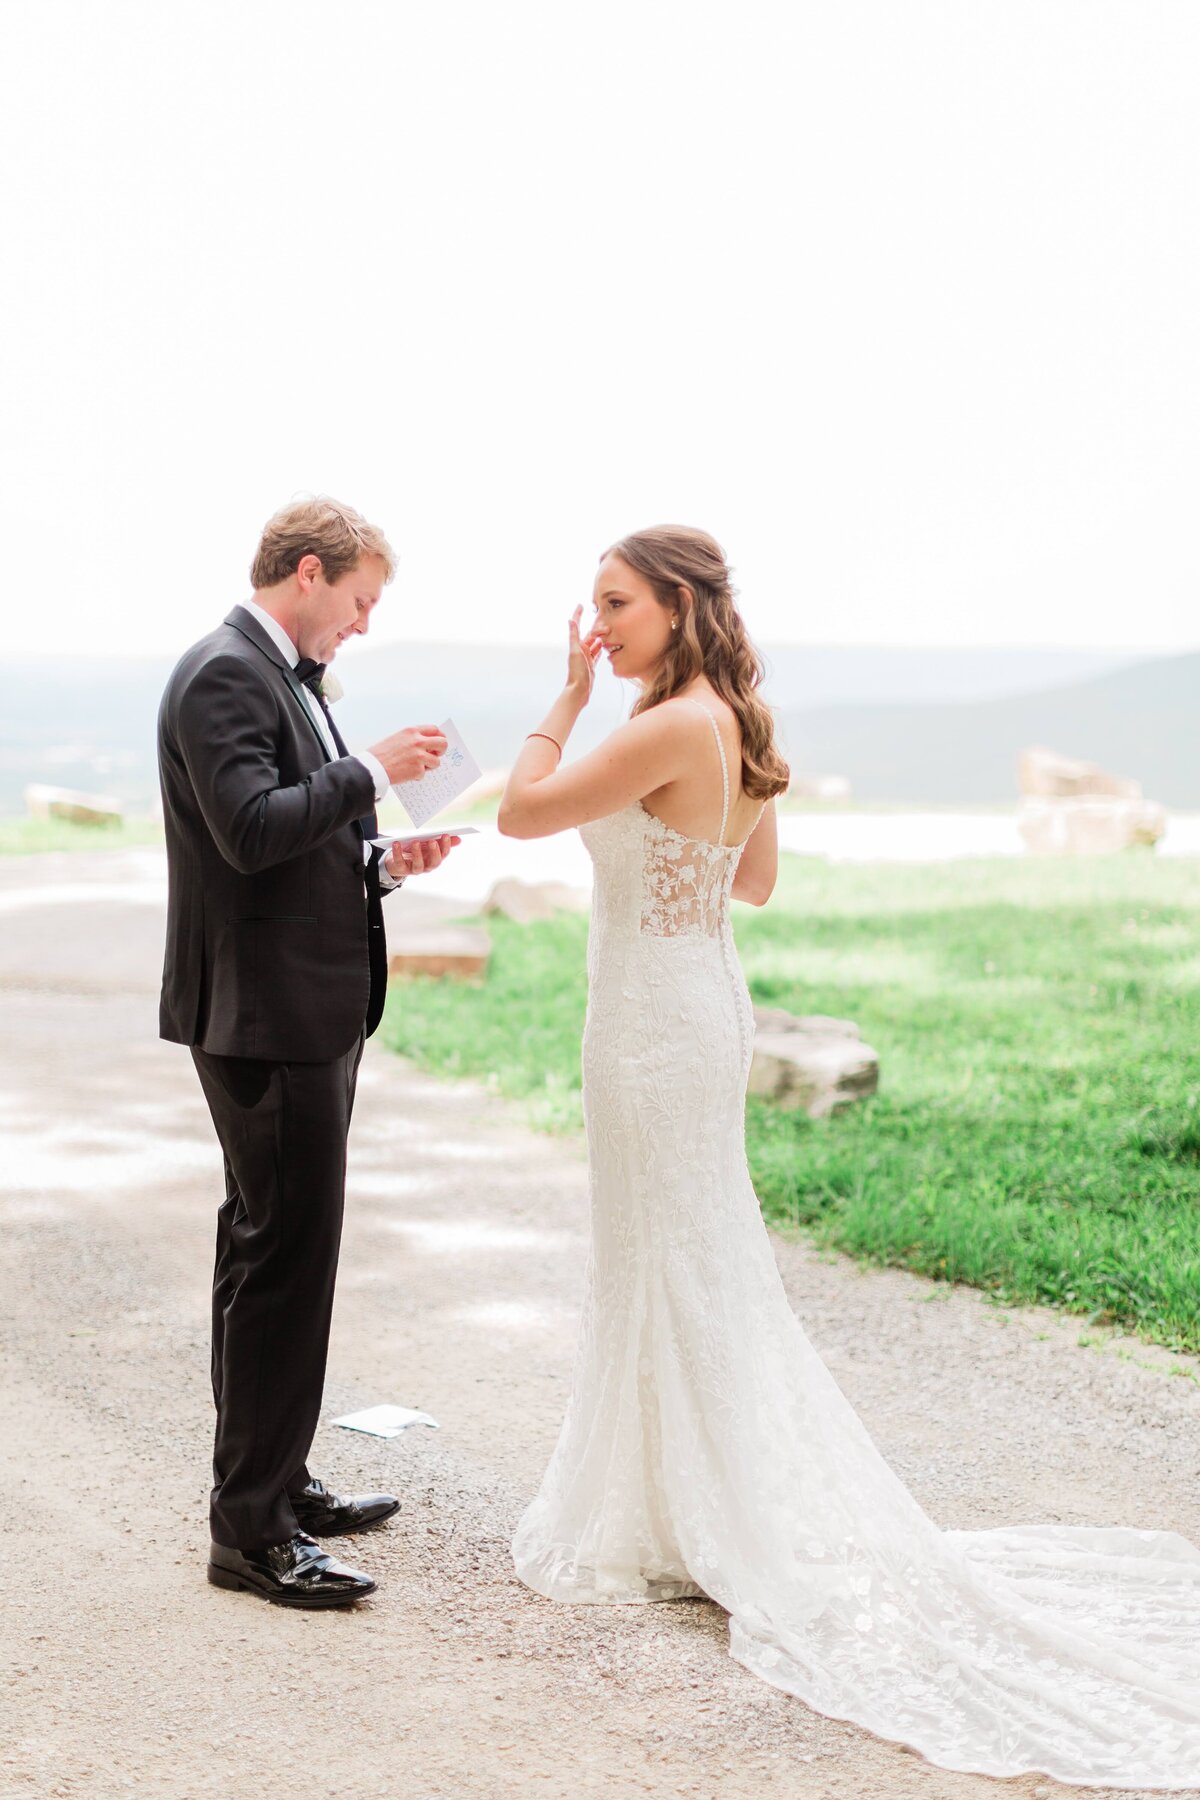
0;857;1200;1800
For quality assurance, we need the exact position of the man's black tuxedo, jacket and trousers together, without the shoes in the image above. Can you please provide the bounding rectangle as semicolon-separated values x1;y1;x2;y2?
158;607;387;1550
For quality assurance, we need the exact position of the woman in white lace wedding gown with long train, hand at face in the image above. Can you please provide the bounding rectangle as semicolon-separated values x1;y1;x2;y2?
498;526;1200;1789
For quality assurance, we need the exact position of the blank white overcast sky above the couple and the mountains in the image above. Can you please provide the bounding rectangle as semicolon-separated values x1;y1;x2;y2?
0;0;1200;652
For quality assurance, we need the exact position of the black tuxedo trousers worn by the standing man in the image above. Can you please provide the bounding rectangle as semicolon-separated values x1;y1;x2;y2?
193;1035;363;1550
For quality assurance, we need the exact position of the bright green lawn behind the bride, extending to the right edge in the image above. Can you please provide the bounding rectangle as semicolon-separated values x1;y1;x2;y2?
385;853;1200;1350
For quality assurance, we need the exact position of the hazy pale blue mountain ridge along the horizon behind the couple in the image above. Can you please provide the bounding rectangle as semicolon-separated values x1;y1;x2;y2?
0;644;1200;814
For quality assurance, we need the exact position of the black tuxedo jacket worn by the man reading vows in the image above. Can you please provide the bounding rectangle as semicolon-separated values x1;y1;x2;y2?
158;607;387;1062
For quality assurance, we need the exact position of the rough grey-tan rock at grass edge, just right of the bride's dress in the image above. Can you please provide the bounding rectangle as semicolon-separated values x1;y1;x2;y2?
750;1006;880;1120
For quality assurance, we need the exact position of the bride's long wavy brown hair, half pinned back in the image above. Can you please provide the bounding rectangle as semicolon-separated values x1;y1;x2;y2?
601;526;788;799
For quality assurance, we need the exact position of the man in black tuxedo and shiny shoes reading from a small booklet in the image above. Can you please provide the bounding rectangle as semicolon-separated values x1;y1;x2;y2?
158;499;457;1606
